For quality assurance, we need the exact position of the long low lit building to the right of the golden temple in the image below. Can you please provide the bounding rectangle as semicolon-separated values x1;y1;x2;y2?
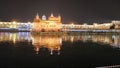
62;23;113;31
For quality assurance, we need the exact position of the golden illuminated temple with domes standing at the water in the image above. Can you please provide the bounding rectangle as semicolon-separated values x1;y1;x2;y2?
32;14;61;32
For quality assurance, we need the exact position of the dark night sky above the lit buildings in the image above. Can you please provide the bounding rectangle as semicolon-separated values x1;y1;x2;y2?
0;0;120;23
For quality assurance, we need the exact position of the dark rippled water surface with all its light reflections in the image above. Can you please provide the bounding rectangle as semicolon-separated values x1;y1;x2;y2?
0;32;120;68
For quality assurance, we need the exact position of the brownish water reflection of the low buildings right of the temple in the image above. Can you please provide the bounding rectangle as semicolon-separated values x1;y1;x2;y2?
62;34;120;48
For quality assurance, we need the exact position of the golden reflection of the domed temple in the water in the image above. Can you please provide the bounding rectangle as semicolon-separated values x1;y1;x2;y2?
32;35;62;55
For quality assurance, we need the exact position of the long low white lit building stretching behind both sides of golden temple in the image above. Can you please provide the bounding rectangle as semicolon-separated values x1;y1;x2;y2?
0;21;120;31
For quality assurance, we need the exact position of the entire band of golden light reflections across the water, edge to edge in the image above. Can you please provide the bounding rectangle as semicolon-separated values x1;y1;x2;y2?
0;32;120;55
